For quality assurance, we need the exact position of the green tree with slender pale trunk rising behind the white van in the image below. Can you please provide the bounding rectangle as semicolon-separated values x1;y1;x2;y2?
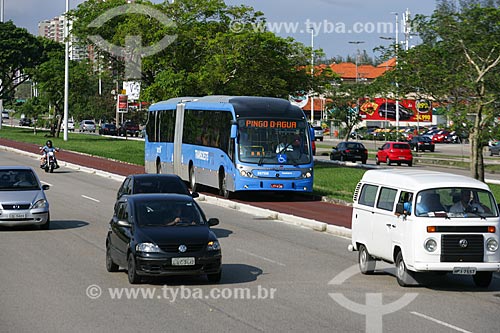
385;1;500;181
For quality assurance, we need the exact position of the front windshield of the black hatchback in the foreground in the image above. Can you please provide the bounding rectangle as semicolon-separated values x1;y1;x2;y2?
135;200;205;227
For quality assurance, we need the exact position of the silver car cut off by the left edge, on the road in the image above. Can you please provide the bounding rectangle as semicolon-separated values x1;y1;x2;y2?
0;166;50;230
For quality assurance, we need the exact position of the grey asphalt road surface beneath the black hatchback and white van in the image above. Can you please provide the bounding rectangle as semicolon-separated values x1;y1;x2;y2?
0;150;500;332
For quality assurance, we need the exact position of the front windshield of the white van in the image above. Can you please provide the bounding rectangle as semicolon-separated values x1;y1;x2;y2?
415;187;498;219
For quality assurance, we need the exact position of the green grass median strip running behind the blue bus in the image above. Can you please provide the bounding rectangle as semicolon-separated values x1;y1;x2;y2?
0;126;500;202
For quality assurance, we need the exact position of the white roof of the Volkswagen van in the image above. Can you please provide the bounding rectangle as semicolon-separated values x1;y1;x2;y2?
361;169;489;191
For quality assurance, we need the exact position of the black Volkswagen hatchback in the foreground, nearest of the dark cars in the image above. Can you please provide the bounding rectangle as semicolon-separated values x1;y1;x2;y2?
106;194;222;284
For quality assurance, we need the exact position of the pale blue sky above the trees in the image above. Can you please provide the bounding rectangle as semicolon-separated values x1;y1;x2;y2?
0;0;436;58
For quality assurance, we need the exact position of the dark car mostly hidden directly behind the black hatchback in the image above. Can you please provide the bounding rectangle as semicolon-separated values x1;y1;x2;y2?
116;173;199;199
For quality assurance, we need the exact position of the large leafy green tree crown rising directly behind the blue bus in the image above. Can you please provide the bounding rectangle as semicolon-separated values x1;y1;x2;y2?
72;0;314;101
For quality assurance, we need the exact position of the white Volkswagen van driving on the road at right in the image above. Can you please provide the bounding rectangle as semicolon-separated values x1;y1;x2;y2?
349;169;500;287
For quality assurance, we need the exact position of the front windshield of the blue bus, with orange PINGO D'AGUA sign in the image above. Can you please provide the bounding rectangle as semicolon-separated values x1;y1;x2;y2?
237;119;312;165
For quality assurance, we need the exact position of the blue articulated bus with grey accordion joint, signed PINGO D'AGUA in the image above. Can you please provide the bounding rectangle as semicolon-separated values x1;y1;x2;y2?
145;96;314;198
